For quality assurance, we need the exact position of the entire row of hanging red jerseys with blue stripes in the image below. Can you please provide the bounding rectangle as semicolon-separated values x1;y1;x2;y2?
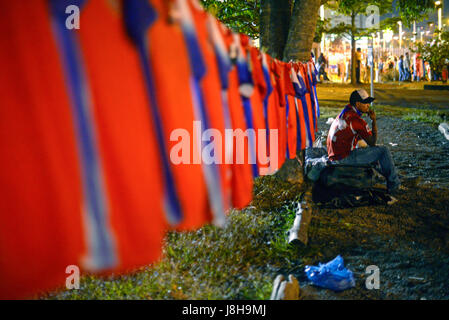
0;0;319;299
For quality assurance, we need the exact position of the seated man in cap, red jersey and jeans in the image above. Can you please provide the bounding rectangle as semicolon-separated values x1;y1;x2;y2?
327;89;400;193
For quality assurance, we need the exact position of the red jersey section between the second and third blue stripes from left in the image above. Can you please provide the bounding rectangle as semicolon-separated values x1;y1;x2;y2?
148;0;212;230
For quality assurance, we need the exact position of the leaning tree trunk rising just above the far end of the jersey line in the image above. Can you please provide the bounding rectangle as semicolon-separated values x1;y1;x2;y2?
283;0;321;62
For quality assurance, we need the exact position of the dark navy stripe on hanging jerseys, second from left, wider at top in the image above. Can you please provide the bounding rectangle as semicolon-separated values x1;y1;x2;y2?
123;0;183;226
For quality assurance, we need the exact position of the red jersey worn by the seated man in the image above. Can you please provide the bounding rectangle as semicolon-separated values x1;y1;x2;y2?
327;105;372;160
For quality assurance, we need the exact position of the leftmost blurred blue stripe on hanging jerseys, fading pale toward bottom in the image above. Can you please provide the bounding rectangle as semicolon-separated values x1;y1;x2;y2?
49;0;118;270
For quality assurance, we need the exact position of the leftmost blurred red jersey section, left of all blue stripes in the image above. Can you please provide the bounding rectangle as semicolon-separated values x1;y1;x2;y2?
0;1;86;299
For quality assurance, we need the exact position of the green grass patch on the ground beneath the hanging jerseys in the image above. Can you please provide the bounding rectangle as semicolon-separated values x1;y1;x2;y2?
45;176;302;299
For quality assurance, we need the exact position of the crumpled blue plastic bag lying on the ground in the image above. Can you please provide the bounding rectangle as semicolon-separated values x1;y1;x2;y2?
304;255;355;291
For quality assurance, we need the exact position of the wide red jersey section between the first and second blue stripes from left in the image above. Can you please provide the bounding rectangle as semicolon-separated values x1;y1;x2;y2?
79;1;168;272
